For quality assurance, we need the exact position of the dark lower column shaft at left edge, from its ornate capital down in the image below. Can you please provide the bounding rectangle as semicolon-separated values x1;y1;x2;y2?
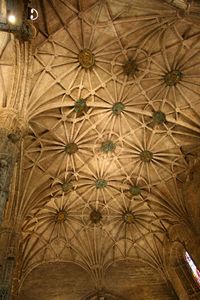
0;108;24;300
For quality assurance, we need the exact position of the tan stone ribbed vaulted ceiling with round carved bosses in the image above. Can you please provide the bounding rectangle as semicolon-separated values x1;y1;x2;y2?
9;0;200;299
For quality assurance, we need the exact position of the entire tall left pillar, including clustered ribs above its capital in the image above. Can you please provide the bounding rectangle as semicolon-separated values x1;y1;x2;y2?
0;27;32;300
